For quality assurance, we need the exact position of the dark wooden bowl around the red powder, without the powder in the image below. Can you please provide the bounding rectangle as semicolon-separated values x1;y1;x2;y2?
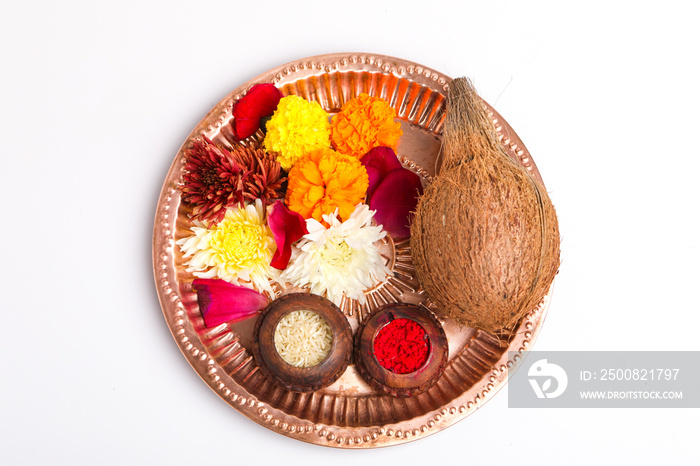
354;303;448;397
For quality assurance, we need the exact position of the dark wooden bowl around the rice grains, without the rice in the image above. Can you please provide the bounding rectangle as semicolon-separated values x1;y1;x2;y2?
253;293;352;392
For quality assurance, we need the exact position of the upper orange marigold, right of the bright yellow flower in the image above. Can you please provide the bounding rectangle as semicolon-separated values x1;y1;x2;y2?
331;94;403;158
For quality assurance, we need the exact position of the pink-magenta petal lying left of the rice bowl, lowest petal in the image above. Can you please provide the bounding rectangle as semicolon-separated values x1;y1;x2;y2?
192;278;267;327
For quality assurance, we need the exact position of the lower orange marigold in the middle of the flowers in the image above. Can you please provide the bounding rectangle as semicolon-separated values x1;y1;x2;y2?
286;148;369;223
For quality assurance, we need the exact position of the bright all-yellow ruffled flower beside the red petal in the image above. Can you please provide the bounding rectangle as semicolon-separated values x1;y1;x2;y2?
264;95;331;171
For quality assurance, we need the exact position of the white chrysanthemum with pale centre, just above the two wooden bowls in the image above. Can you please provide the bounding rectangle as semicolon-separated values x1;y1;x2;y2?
280;204;391;306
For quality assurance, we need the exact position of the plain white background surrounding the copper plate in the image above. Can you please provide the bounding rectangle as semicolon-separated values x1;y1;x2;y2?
0;0;700;466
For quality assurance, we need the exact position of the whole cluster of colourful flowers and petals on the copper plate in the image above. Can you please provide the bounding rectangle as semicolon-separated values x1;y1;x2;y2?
177;84;422;327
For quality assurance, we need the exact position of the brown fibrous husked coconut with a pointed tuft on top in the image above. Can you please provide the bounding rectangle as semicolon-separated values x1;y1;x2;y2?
411;78;559;332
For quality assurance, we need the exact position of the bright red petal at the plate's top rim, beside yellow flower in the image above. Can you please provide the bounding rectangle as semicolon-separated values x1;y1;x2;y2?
231;83;282;140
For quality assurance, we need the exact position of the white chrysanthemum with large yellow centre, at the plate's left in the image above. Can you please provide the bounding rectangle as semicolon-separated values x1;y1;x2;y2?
177;199;278;294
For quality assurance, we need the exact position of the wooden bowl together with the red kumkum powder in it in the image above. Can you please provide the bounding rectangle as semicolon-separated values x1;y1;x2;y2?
354;303;448;397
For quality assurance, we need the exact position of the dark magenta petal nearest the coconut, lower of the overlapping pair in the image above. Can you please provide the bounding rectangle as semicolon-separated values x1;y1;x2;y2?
369;168;423;237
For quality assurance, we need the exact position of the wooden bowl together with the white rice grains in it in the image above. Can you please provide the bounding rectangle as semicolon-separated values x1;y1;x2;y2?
253;293;352;392
